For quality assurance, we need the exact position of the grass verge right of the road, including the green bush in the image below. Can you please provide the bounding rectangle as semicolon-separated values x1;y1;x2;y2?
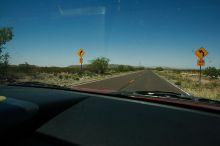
154;67;220;100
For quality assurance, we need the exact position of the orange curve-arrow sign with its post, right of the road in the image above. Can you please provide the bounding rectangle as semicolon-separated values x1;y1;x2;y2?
195;47;208;84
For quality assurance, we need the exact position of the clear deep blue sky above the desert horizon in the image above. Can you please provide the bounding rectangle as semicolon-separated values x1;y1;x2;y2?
0;0;220;68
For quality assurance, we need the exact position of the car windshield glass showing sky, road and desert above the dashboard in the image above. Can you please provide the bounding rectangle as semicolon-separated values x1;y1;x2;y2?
0;0;220;100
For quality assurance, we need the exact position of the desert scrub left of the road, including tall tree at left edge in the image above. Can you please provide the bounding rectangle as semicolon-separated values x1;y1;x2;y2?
0;27;144;87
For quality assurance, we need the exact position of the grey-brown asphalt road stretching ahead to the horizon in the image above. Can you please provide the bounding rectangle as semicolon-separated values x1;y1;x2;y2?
77;70;185;94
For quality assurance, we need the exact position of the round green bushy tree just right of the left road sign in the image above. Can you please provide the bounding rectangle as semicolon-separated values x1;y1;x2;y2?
90;57;110;74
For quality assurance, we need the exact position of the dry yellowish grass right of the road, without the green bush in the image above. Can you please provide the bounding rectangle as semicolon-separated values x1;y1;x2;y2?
155;70;220;100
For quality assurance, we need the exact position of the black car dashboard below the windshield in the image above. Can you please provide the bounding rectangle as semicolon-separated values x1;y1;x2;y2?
0;86;220;146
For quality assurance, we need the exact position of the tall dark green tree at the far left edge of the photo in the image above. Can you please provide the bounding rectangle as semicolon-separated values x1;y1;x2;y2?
0;27;13;79
